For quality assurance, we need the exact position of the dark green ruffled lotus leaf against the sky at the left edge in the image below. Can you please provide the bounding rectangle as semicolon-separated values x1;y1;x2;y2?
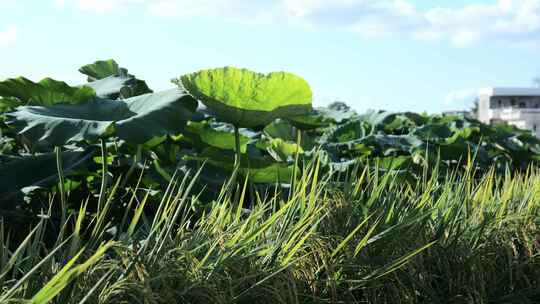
0;77;96;106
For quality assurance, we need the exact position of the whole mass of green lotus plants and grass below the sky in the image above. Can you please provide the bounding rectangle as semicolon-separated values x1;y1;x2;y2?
0;60;540;303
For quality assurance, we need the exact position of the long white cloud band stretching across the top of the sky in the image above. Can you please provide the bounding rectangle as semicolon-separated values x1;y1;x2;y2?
50;0;540;47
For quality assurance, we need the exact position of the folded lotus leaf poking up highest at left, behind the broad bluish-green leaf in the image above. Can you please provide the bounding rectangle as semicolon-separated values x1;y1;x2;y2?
79;59;152;99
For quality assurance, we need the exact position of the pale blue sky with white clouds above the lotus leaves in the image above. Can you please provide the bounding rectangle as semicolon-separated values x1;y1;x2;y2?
0;0;540;112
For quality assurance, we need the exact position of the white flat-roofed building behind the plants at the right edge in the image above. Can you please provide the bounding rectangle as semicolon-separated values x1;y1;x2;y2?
478;87;540;137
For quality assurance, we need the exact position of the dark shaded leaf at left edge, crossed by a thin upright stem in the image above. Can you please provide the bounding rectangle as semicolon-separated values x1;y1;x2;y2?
0;149;94;207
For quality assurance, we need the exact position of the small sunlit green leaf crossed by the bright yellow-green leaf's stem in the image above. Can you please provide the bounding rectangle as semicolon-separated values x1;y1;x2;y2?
185;121;250;153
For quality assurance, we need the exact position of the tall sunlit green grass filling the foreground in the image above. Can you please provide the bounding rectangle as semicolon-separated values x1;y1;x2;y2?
0;165;540;303
